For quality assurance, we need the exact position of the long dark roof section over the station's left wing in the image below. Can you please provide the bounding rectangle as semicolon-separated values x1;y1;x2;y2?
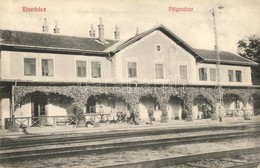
0;30;117;51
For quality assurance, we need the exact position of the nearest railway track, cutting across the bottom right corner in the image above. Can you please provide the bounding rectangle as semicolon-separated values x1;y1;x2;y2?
102;147;260;168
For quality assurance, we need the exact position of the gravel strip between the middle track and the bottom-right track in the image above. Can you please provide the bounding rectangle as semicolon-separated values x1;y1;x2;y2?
1;137;260;168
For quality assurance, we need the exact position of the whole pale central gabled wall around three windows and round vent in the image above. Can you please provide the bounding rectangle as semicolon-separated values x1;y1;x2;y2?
114;31;196;83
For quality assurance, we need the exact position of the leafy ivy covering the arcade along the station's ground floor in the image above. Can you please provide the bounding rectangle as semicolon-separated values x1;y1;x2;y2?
14;86;260;118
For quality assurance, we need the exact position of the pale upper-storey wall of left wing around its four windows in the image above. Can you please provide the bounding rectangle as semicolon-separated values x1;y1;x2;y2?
1;51;112;82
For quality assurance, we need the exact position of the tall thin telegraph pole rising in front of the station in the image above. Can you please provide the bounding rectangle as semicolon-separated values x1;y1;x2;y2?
210;6;224;121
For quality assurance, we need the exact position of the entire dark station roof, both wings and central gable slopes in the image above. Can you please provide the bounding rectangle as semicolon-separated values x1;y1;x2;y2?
0;25;258;66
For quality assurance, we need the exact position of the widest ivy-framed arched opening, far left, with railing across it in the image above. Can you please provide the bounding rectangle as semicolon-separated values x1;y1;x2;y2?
14;91;73;126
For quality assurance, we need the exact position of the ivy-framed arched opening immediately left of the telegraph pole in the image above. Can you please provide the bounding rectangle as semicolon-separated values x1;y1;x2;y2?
192;95;213;119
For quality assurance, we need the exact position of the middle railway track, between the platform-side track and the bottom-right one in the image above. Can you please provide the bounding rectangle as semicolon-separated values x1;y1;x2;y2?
0;131;260;163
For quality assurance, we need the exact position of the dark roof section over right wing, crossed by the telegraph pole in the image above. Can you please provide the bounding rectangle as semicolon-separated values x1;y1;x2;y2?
194;49;258;66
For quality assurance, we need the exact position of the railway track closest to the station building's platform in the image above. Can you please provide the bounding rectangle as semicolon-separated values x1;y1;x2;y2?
0;124;260;150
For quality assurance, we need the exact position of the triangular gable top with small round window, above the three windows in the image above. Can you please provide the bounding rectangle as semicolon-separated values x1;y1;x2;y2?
118;30;194;62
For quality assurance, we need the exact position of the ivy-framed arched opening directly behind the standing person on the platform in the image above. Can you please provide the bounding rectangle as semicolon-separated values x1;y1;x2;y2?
137;95;158;121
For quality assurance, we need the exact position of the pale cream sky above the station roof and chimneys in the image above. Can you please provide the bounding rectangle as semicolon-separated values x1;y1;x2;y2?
0;0;260;53
